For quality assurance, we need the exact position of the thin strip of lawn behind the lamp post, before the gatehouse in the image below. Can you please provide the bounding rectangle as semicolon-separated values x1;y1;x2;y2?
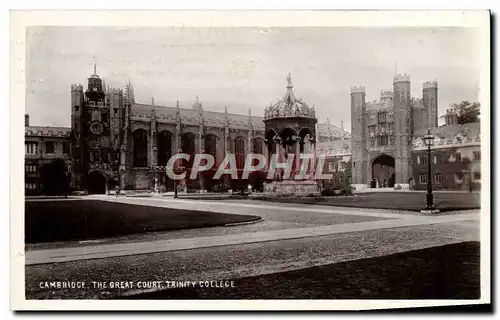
254;192;481;212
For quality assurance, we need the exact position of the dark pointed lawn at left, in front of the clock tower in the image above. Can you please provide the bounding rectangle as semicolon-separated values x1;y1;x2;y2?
25;200;260;243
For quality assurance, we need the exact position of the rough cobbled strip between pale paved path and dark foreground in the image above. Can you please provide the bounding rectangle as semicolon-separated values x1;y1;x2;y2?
25;221;479;299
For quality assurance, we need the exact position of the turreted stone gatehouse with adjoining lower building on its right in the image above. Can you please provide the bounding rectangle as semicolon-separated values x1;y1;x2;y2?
350;74;480;190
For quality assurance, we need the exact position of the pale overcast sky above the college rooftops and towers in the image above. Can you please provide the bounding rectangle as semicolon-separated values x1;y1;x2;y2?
26;27;480;131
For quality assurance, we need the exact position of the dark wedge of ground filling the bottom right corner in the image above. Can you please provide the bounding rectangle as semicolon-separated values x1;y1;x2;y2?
126;242;480;299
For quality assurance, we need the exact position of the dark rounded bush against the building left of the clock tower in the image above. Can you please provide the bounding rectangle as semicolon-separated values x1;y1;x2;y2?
40;159;69;196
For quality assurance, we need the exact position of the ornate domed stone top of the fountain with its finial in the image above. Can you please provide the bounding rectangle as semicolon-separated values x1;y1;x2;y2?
264;74;316;120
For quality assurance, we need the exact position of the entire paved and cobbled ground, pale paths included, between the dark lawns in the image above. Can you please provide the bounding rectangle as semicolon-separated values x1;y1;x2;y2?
25;196;479;298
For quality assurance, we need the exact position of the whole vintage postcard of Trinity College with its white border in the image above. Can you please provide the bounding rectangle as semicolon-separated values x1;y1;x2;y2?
10;11;491;310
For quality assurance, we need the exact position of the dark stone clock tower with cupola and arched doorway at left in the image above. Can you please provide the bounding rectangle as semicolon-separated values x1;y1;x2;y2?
72;64;123;193
